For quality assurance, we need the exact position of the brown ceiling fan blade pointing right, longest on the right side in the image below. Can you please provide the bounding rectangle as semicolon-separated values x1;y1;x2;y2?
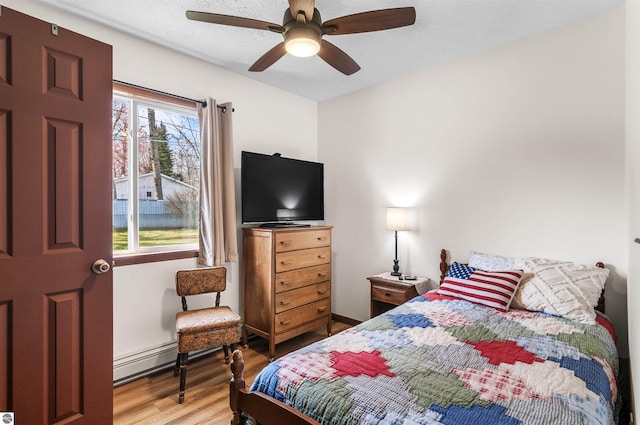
322;7;416;35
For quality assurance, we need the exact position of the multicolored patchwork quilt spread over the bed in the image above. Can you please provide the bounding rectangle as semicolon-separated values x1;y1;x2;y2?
252;292;618;425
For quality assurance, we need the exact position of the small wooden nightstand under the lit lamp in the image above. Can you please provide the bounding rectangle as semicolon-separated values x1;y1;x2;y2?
367;273;430;317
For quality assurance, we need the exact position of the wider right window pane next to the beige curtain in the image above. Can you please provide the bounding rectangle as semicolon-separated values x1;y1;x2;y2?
136;104;200;247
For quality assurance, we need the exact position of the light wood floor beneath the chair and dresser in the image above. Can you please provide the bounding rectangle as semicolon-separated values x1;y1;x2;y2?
113;321;350;425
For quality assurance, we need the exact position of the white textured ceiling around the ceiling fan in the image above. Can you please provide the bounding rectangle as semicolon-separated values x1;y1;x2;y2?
33;0;624;101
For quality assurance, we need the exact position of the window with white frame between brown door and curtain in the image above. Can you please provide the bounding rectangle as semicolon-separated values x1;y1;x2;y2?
112;85;200;256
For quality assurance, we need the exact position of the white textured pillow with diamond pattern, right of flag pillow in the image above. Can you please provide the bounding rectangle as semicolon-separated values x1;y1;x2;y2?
512;257;609;324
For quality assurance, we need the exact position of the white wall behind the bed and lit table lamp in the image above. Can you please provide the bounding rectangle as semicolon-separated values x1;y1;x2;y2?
319;9;627;353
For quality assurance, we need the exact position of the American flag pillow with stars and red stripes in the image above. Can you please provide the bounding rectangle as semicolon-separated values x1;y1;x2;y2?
438;263;524;311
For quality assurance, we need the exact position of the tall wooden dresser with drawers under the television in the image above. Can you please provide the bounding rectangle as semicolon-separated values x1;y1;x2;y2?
242;226;332;360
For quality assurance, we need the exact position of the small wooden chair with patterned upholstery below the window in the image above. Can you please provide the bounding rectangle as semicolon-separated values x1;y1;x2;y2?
173;267;241;403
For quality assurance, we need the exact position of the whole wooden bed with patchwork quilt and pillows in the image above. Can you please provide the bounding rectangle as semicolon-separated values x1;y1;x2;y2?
230;250;619;425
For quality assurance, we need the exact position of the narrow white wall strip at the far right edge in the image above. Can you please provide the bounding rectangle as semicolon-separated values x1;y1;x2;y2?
626;0;640;414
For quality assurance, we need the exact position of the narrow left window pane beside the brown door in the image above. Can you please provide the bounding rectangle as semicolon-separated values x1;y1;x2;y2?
111;95;131;251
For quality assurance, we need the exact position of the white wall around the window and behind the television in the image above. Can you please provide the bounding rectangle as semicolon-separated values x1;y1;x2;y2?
2;0;318;380
